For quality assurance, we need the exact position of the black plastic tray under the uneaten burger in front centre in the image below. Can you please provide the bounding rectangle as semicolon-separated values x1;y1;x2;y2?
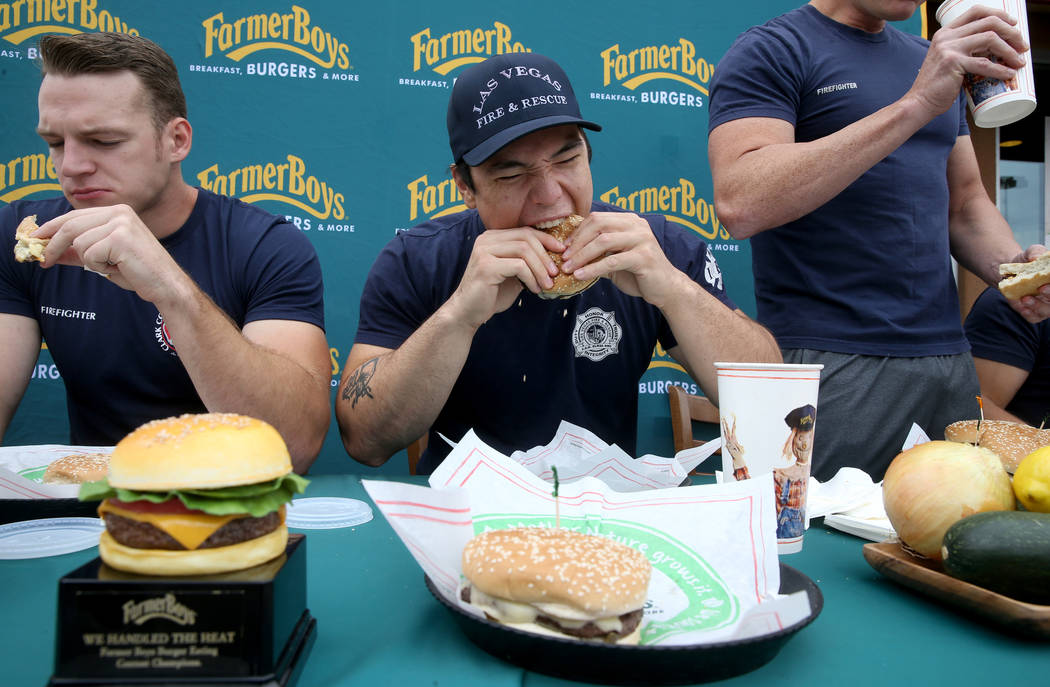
424;563;824;685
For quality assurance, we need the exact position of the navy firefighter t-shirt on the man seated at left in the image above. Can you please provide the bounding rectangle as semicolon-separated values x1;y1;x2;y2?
0;189;324;445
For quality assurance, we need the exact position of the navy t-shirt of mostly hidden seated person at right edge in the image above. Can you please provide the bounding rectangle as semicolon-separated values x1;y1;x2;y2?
966;287;1050;426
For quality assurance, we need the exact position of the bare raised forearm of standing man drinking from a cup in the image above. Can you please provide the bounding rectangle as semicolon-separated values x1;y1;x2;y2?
709;99;926;238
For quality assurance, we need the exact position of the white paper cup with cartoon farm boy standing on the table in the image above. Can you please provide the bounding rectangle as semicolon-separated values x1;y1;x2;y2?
715;362;824;554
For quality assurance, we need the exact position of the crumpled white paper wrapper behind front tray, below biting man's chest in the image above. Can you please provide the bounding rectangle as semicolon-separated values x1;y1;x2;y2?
510;420;721;492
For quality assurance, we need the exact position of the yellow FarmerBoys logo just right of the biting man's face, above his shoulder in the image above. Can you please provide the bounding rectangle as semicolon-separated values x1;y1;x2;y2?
601;179;730;243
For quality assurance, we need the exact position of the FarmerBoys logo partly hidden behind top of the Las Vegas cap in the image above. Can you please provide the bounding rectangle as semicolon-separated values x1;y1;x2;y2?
398;21;532;88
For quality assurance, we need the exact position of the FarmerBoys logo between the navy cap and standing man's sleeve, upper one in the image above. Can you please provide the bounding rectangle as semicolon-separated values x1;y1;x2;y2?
590;38;714;107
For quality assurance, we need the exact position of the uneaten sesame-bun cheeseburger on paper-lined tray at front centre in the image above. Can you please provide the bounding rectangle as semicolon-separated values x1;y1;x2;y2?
460;527;652;644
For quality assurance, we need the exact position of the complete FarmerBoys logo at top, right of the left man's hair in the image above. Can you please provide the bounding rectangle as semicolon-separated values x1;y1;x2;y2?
195;5;359;82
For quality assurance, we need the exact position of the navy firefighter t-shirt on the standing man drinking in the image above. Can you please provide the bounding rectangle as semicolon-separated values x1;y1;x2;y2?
709;5;968;356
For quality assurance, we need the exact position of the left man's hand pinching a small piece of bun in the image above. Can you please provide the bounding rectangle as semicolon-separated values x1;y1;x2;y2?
34;205;185;304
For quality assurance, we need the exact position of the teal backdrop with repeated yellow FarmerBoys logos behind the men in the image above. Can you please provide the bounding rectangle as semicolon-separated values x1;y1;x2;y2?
0;0;925;474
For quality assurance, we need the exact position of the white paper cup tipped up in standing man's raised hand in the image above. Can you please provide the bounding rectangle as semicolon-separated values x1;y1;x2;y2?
937;0;1035;128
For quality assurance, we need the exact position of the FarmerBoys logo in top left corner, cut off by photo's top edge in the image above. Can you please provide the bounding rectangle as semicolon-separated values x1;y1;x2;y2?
0;0;139;46
